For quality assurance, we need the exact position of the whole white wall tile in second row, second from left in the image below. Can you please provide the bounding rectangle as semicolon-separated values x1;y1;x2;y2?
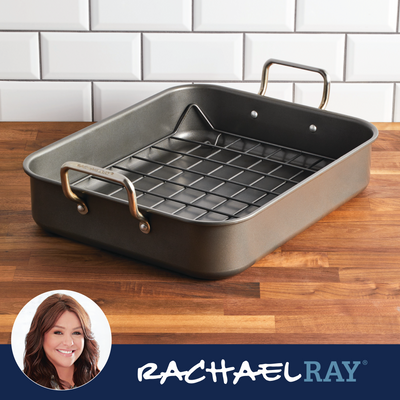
42;32;141;80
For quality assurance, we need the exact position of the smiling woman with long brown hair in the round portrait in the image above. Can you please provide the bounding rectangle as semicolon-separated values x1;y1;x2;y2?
13;293;111;390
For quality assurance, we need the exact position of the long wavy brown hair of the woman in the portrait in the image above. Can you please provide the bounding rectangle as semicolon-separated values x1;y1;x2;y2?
24;293;100;389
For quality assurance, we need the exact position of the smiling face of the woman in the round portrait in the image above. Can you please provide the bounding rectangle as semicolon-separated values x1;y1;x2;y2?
43;311;84;369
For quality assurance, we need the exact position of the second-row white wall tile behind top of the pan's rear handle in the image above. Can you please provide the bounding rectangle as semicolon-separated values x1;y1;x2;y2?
245;33;345;81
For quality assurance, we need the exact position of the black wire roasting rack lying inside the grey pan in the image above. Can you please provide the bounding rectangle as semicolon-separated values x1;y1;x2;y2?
73;104;334;222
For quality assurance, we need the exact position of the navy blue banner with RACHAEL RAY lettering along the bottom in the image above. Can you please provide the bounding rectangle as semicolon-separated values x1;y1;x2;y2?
0;345;400;400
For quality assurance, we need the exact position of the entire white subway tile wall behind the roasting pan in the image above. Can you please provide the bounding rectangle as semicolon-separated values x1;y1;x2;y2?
0;0;400;122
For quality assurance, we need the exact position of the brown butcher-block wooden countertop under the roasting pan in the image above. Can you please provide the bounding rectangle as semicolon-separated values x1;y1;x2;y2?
0;122;400;344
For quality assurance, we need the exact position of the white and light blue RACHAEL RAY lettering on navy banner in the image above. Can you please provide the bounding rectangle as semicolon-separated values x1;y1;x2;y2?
137;360;367;385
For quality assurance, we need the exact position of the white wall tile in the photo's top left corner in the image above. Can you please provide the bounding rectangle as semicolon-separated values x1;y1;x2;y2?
0;0;89;31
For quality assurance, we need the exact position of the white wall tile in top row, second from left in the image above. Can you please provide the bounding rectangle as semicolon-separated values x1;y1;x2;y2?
91;0;192;31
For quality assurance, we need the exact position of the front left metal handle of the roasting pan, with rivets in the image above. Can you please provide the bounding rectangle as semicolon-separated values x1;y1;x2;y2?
60;161;150;233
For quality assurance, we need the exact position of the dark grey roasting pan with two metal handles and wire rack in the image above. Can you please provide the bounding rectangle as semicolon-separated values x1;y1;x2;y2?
23;60;378;279
